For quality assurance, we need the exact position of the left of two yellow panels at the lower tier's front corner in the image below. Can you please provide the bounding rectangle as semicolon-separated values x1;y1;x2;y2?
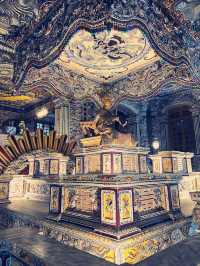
101;190;117;225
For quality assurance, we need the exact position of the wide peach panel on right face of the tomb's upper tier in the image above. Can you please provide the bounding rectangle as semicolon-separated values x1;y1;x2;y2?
123;153;139;172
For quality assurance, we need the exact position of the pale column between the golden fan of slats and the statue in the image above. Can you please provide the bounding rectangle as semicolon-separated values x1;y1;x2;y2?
55;100;70;138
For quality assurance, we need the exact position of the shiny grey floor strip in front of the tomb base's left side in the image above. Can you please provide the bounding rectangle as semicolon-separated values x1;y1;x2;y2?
0;228;117;266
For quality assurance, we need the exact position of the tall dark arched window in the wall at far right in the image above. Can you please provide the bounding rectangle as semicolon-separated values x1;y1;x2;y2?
168;106;196;152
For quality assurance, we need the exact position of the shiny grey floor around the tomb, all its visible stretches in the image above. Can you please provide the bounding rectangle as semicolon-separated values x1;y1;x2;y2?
0;200;200;266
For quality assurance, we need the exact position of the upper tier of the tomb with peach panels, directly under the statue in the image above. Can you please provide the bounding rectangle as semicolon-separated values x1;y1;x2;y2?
74;145;149;175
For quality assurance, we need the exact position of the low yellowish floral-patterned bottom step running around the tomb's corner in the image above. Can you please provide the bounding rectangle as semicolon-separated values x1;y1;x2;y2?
43;218;191;265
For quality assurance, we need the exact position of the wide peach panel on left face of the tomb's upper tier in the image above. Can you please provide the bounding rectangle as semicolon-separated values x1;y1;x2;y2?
84;154;101;174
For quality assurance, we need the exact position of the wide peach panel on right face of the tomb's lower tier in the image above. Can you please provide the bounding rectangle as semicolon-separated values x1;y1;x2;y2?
134;186;169;213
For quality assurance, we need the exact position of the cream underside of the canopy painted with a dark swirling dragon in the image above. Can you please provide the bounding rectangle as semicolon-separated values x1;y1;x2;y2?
56;29;160;83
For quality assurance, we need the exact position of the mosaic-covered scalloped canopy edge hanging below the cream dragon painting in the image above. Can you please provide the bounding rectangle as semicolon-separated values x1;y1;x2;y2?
21;61;198;105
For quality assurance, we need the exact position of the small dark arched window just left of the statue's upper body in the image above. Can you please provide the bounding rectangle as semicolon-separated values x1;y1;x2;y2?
81;101;97;121
